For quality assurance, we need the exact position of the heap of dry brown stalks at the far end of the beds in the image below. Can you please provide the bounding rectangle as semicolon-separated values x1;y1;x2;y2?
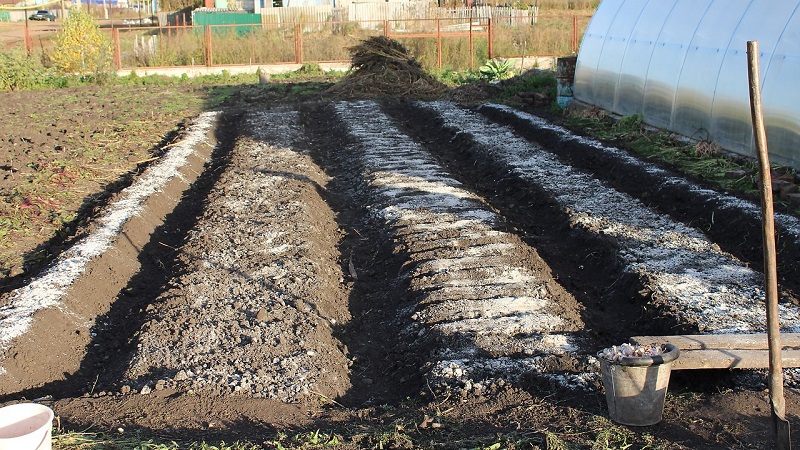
329;36;447;100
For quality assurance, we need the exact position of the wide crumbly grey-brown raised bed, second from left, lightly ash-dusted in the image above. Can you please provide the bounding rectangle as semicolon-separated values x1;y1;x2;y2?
126;108;350;401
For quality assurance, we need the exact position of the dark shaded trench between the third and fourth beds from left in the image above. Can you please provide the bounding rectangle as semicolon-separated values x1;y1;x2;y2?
384;101;692;348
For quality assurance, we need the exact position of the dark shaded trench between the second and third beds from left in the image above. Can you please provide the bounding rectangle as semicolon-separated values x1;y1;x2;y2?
301;104;424;407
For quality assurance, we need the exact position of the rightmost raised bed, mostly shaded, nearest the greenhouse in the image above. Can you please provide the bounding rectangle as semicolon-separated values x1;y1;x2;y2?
478;104;800;298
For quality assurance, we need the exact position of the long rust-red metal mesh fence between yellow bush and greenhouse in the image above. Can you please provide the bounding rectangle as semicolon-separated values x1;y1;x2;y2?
109;16;590;70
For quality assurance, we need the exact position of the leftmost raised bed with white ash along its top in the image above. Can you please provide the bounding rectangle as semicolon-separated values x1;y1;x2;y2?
0;112;219;394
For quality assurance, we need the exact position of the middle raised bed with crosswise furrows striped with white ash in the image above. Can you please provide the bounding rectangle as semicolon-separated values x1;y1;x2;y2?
336;102;592;391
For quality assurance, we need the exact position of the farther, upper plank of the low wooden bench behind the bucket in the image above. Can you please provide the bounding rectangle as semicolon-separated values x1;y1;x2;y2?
631;333;800;351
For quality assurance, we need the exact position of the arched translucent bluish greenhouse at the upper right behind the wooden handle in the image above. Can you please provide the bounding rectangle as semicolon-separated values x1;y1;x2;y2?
575;0;800;168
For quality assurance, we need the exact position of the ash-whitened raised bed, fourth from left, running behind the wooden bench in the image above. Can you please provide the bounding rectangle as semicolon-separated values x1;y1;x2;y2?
419;102;800;333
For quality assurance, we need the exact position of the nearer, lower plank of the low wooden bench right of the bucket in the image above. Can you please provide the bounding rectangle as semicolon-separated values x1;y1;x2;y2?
672;349;800;370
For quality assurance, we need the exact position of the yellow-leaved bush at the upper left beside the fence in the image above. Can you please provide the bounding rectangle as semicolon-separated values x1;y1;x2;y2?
53;8;113;74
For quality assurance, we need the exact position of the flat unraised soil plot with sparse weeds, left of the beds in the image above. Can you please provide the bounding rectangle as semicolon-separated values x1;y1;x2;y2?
0;86;204;289
